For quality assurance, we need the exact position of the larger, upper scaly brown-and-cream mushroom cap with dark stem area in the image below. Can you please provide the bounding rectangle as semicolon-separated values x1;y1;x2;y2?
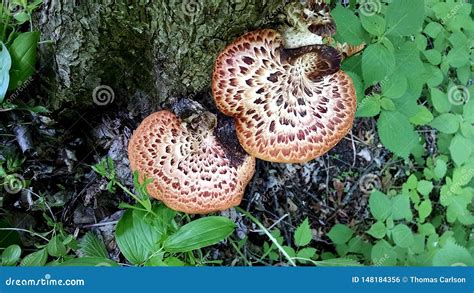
212;29;356;163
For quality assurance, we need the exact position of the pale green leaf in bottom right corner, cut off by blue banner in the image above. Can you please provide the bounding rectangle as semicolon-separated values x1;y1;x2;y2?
433;241;474;266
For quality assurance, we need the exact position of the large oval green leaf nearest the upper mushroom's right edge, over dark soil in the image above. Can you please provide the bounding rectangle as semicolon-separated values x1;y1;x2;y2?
377;111;419;158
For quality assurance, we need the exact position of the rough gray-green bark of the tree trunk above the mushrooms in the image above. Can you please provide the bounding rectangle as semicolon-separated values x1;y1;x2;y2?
36;0;288;109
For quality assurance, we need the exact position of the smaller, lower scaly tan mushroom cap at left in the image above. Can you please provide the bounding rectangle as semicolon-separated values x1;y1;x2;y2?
128;110;255;214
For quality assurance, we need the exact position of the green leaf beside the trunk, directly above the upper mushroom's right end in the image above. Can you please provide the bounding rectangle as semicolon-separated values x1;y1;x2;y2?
331;6;364;45
